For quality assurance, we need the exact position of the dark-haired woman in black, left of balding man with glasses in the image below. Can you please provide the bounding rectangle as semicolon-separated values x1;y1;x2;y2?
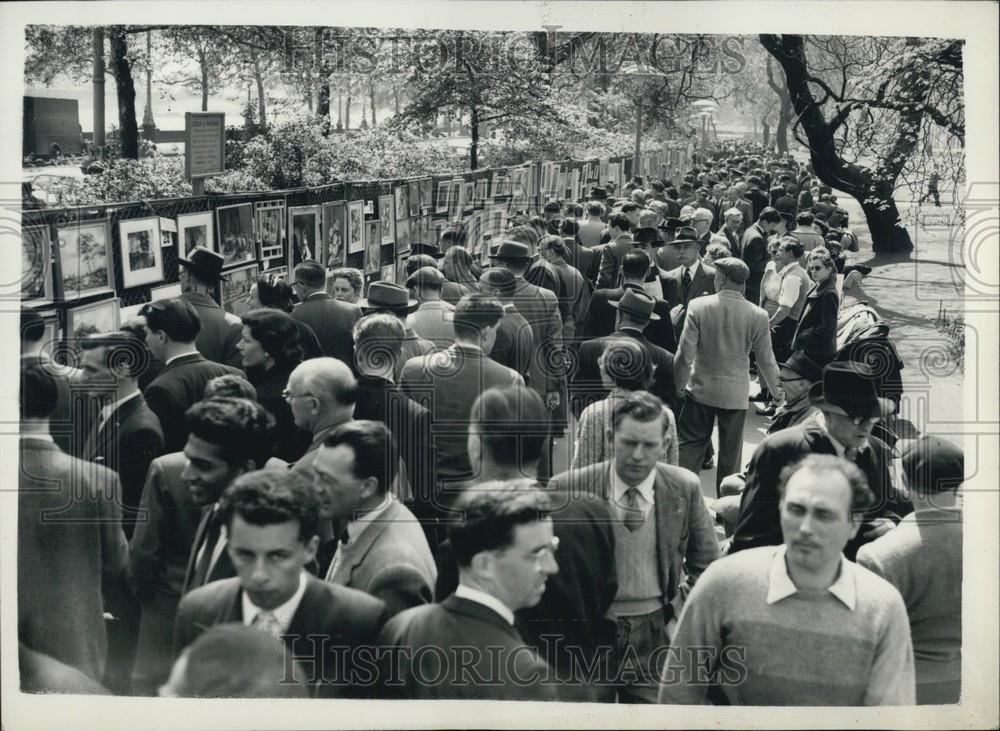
238;308;312;462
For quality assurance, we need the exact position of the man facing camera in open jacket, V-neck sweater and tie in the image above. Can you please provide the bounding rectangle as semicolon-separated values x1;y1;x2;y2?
550;391;719;703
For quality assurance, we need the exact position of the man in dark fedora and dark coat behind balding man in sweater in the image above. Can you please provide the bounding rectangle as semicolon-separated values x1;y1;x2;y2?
728;361;913;560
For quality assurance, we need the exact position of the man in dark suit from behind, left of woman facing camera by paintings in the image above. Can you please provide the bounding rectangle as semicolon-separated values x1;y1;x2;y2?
292;260;361;368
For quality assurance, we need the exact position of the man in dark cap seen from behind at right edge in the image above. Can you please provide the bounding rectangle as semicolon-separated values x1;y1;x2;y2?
858;436;965;704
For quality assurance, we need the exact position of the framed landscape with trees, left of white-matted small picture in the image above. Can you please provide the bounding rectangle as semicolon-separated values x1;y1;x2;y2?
56;219;114;300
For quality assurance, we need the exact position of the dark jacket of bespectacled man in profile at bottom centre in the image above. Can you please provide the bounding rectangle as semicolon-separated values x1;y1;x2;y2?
378;596;556;700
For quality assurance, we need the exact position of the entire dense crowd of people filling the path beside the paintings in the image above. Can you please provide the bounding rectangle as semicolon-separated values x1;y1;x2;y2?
18;144;964;706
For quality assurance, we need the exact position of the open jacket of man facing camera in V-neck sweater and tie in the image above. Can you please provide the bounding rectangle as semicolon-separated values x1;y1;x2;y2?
549;462;719;617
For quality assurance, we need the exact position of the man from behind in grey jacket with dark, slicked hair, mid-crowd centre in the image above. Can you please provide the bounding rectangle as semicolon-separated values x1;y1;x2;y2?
400;294;524;512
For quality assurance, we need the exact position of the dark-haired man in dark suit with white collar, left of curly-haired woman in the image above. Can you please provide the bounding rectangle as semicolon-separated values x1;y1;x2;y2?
141;298;243;452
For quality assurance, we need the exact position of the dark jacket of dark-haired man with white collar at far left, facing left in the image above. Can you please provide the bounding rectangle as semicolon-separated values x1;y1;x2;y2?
83;394;163;538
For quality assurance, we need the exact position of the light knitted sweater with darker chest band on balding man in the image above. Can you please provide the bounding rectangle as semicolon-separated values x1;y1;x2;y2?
660;546;915;706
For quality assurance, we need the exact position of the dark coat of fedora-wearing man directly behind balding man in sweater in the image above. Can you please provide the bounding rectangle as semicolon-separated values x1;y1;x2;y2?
730;420;913;560
